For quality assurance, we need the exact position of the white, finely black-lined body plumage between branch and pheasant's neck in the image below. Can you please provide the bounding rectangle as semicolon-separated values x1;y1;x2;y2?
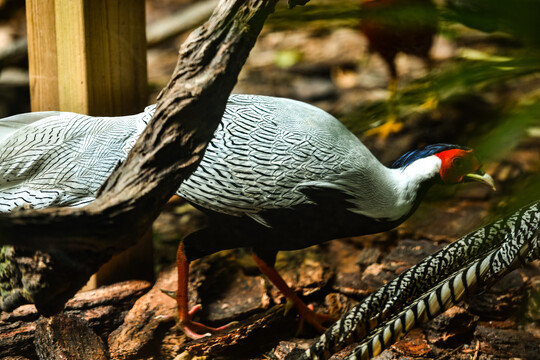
178;95;372;224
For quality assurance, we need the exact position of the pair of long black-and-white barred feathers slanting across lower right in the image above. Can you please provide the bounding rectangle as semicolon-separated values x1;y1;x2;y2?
300;202;540;360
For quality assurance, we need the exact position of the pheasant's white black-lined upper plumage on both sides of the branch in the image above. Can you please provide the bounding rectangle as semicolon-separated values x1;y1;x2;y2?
0;95;386;225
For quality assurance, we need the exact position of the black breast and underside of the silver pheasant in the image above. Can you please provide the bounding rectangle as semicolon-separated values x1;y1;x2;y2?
181;190;406;260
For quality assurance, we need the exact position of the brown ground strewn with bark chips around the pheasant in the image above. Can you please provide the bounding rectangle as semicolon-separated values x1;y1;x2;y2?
0;0;540;359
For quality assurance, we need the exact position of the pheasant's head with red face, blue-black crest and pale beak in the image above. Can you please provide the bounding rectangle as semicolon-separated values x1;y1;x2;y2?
392;144;495;190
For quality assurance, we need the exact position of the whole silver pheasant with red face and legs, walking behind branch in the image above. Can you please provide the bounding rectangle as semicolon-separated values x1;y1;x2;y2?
0;95;493;337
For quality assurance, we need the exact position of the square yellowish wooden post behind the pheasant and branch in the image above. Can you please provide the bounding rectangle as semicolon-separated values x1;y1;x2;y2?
26;0;152;288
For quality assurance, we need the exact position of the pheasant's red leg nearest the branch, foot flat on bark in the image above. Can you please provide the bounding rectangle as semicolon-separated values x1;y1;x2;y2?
176;242;227;339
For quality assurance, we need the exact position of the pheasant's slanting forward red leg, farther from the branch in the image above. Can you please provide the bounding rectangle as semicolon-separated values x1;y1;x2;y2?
253;254;336;332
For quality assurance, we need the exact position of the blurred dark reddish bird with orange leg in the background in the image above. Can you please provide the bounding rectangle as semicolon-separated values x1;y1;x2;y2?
360;0;438;138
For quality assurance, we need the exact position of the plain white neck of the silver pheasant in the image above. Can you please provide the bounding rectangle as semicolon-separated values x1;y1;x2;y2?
350;155;441;220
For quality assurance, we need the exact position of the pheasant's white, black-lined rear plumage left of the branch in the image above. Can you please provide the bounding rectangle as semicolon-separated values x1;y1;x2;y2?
0;112;145;212
